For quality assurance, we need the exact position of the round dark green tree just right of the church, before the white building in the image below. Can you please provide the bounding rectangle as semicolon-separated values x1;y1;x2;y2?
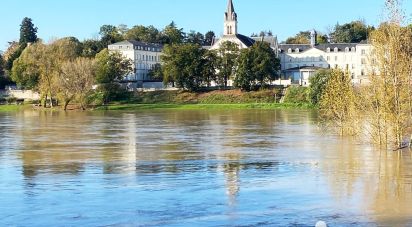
235;42;280;91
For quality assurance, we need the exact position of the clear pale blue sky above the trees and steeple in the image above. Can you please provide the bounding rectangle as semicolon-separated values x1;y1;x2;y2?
0;0;412;50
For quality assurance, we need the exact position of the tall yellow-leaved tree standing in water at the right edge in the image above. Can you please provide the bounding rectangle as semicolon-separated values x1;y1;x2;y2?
362;0;412;148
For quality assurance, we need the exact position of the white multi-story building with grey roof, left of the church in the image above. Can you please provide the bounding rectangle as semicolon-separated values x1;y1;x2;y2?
109;40;163;86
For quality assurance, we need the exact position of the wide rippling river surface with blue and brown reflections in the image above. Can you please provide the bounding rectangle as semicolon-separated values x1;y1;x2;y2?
0;110;412;226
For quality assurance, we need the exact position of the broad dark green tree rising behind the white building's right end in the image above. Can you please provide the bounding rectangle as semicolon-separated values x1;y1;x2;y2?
331;21;375;43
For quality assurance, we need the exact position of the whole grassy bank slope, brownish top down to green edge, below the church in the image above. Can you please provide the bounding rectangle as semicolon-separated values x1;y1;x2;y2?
101;89;313;110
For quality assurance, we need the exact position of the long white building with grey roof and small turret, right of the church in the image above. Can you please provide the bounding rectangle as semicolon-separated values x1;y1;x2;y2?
279;31;372;86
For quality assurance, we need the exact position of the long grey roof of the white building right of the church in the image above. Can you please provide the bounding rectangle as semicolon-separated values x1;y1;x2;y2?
279;43;358;53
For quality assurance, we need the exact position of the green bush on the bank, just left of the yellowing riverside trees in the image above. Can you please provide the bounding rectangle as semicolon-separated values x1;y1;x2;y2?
309;69;333;105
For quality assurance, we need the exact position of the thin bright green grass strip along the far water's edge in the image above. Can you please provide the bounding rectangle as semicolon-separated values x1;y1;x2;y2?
97;103;313;111
